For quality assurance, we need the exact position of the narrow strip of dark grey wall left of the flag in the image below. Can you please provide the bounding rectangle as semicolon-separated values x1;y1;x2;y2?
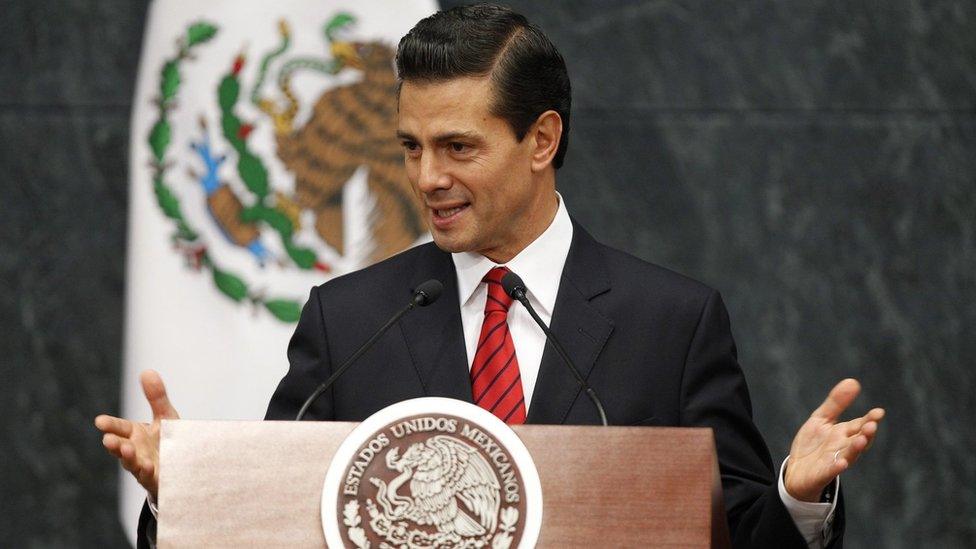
0;0;146;547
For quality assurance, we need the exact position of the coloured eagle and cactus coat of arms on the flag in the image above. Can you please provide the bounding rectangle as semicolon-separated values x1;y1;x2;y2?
140;12;424;322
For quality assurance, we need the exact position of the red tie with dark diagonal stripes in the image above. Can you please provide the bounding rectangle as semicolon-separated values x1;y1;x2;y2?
471;267;525;425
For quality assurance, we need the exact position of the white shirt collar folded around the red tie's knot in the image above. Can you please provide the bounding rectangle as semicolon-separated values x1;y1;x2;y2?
451;193;573;315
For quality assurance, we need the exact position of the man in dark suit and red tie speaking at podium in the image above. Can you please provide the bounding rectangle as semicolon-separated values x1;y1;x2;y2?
96;2;884;547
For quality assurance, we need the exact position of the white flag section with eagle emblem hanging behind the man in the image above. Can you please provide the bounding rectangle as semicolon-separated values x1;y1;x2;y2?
120;0;436;539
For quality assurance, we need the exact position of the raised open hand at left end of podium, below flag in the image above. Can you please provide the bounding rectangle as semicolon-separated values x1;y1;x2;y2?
95;370;180;498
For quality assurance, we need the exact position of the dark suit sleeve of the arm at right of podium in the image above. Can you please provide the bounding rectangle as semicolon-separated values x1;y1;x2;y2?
681;291;843;549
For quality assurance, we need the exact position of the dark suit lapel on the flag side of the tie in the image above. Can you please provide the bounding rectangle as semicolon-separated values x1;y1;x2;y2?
399;244;472;402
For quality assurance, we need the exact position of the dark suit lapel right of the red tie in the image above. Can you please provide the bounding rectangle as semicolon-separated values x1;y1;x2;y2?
527;220;613;424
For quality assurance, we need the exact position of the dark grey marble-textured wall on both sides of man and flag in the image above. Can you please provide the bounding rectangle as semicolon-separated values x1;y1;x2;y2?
0;0;976;547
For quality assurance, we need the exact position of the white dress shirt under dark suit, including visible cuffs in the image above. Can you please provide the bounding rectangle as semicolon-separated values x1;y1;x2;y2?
148;194;840;549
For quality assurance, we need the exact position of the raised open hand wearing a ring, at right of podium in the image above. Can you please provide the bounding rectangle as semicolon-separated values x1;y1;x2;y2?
783;379;885;502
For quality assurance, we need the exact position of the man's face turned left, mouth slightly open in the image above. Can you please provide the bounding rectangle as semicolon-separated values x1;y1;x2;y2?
397;77;555;262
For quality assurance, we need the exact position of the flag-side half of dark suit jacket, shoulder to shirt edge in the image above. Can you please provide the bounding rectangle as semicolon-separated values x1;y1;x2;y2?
265;244;470;421
